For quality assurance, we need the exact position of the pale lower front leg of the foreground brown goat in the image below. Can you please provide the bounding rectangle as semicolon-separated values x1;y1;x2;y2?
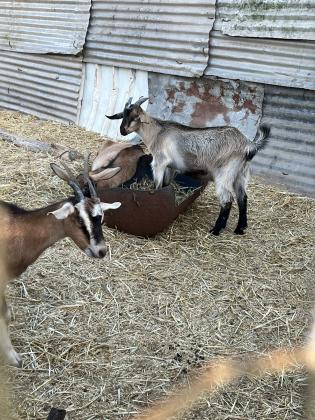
0;295;22;367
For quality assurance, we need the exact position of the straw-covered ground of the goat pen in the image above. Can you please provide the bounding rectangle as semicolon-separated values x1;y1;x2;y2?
0;111;315;420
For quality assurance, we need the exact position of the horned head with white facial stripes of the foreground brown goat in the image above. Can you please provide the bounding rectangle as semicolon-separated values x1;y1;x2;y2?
51;156;121;258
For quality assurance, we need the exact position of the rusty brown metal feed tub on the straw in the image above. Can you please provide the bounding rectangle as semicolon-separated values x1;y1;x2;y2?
98;155;206;237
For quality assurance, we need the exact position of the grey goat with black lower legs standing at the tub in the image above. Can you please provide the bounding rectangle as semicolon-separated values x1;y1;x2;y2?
107;97;270;235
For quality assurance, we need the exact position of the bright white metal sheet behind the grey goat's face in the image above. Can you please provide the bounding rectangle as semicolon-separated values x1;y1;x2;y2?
79;64;148;140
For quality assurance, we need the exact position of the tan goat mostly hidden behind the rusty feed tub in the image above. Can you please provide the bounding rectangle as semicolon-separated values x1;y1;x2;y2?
89;140;144;188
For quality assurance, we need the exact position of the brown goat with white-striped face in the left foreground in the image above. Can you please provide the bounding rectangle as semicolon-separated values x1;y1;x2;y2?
0;159;121;367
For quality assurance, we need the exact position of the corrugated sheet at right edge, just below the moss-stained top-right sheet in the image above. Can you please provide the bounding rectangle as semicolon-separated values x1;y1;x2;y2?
205;31;315;89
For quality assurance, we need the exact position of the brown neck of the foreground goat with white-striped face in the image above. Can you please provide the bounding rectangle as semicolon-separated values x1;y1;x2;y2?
1;201;66;279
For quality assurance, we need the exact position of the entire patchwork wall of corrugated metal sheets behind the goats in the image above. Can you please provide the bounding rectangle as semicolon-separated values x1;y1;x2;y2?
0;0;315;194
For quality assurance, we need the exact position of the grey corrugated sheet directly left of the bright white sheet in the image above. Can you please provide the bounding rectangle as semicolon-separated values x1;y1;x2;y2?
0;50;82;122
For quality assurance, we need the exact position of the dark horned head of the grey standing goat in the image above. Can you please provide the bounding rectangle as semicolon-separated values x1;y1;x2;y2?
106;96;149;136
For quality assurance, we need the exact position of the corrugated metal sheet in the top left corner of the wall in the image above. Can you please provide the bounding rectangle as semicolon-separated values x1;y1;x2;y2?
0;0;91;54
